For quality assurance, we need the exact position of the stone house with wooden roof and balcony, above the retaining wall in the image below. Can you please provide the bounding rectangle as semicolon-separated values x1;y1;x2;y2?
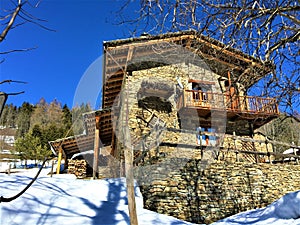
50;30;279;174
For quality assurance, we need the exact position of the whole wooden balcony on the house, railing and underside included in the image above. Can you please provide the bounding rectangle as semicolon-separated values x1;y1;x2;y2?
177;90;279;132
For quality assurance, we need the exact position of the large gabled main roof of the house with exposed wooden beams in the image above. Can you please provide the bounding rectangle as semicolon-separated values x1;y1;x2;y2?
103;30;272;108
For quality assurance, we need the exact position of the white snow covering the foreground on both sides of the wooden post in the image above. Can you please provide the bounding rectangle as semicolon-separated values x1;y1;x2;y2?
0;169;300;225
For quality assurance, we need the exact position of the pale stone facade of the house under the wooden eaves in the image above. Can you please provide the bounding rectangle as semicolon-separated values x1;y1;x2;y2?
114;64;271;164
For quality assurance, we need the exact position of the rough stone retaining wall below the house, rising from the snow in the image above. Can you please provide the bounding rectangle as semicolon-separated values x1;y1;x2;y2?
136;158;300;224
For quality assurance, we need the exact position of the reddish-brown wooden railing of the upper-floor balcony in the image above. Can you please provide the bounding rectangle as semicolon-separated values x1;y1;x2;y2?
177;90;279;115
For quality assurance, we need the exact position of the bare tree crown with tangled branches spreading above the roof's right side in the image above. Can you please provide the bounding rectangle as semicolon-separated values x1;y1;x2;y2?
117;0;300;115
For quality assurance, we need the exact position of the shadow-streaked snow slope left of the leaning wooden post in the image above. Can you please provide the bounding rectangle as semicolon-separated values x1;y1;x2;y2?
0;176;138;225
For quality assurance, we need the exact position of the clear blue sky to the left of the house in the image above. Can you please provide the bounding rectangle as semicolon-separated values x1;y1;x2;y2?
0;0;134;107
